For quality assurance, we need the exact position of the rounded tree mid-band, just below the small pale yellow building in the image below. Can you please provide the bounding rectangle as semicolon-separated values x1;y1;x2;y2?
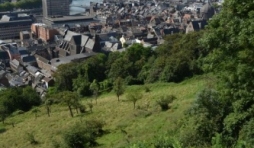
106;44;154;84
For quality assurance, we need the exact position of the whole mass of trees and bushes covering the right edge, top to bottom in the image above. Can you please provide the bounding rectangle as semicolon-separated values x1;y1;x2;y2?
178;0;254;147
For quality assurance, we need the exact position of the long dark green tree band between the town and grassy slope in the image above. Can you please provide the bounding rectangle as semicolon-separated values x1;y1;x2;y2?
54;32;205;97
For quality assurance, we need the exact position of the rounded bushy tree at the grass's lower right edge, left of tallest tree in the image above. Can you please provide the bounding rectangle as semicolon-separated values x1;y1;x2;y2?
183;88;225;147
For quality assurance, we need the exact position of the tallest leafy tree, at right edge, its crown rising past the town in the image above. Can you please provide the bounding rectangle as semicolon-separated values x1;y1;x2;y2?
200;0;254;147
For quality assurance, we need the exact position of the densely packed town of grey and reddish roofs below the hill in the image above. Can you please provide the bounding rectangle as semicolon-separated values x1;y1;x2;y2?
0;0;219;97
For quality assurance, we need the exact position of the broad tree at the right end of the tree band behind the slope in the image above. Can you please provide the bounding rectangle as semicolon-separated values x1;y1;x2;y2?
146;31;206;82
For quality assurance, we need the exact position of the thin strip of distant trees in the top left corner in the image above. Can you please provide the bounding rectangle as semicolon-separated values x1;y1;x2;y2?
0;0;42;11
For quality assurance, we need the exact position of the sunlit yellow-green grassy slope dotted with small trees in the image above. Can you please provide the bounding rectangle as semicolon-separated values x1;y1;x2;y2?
0;76;207;148
